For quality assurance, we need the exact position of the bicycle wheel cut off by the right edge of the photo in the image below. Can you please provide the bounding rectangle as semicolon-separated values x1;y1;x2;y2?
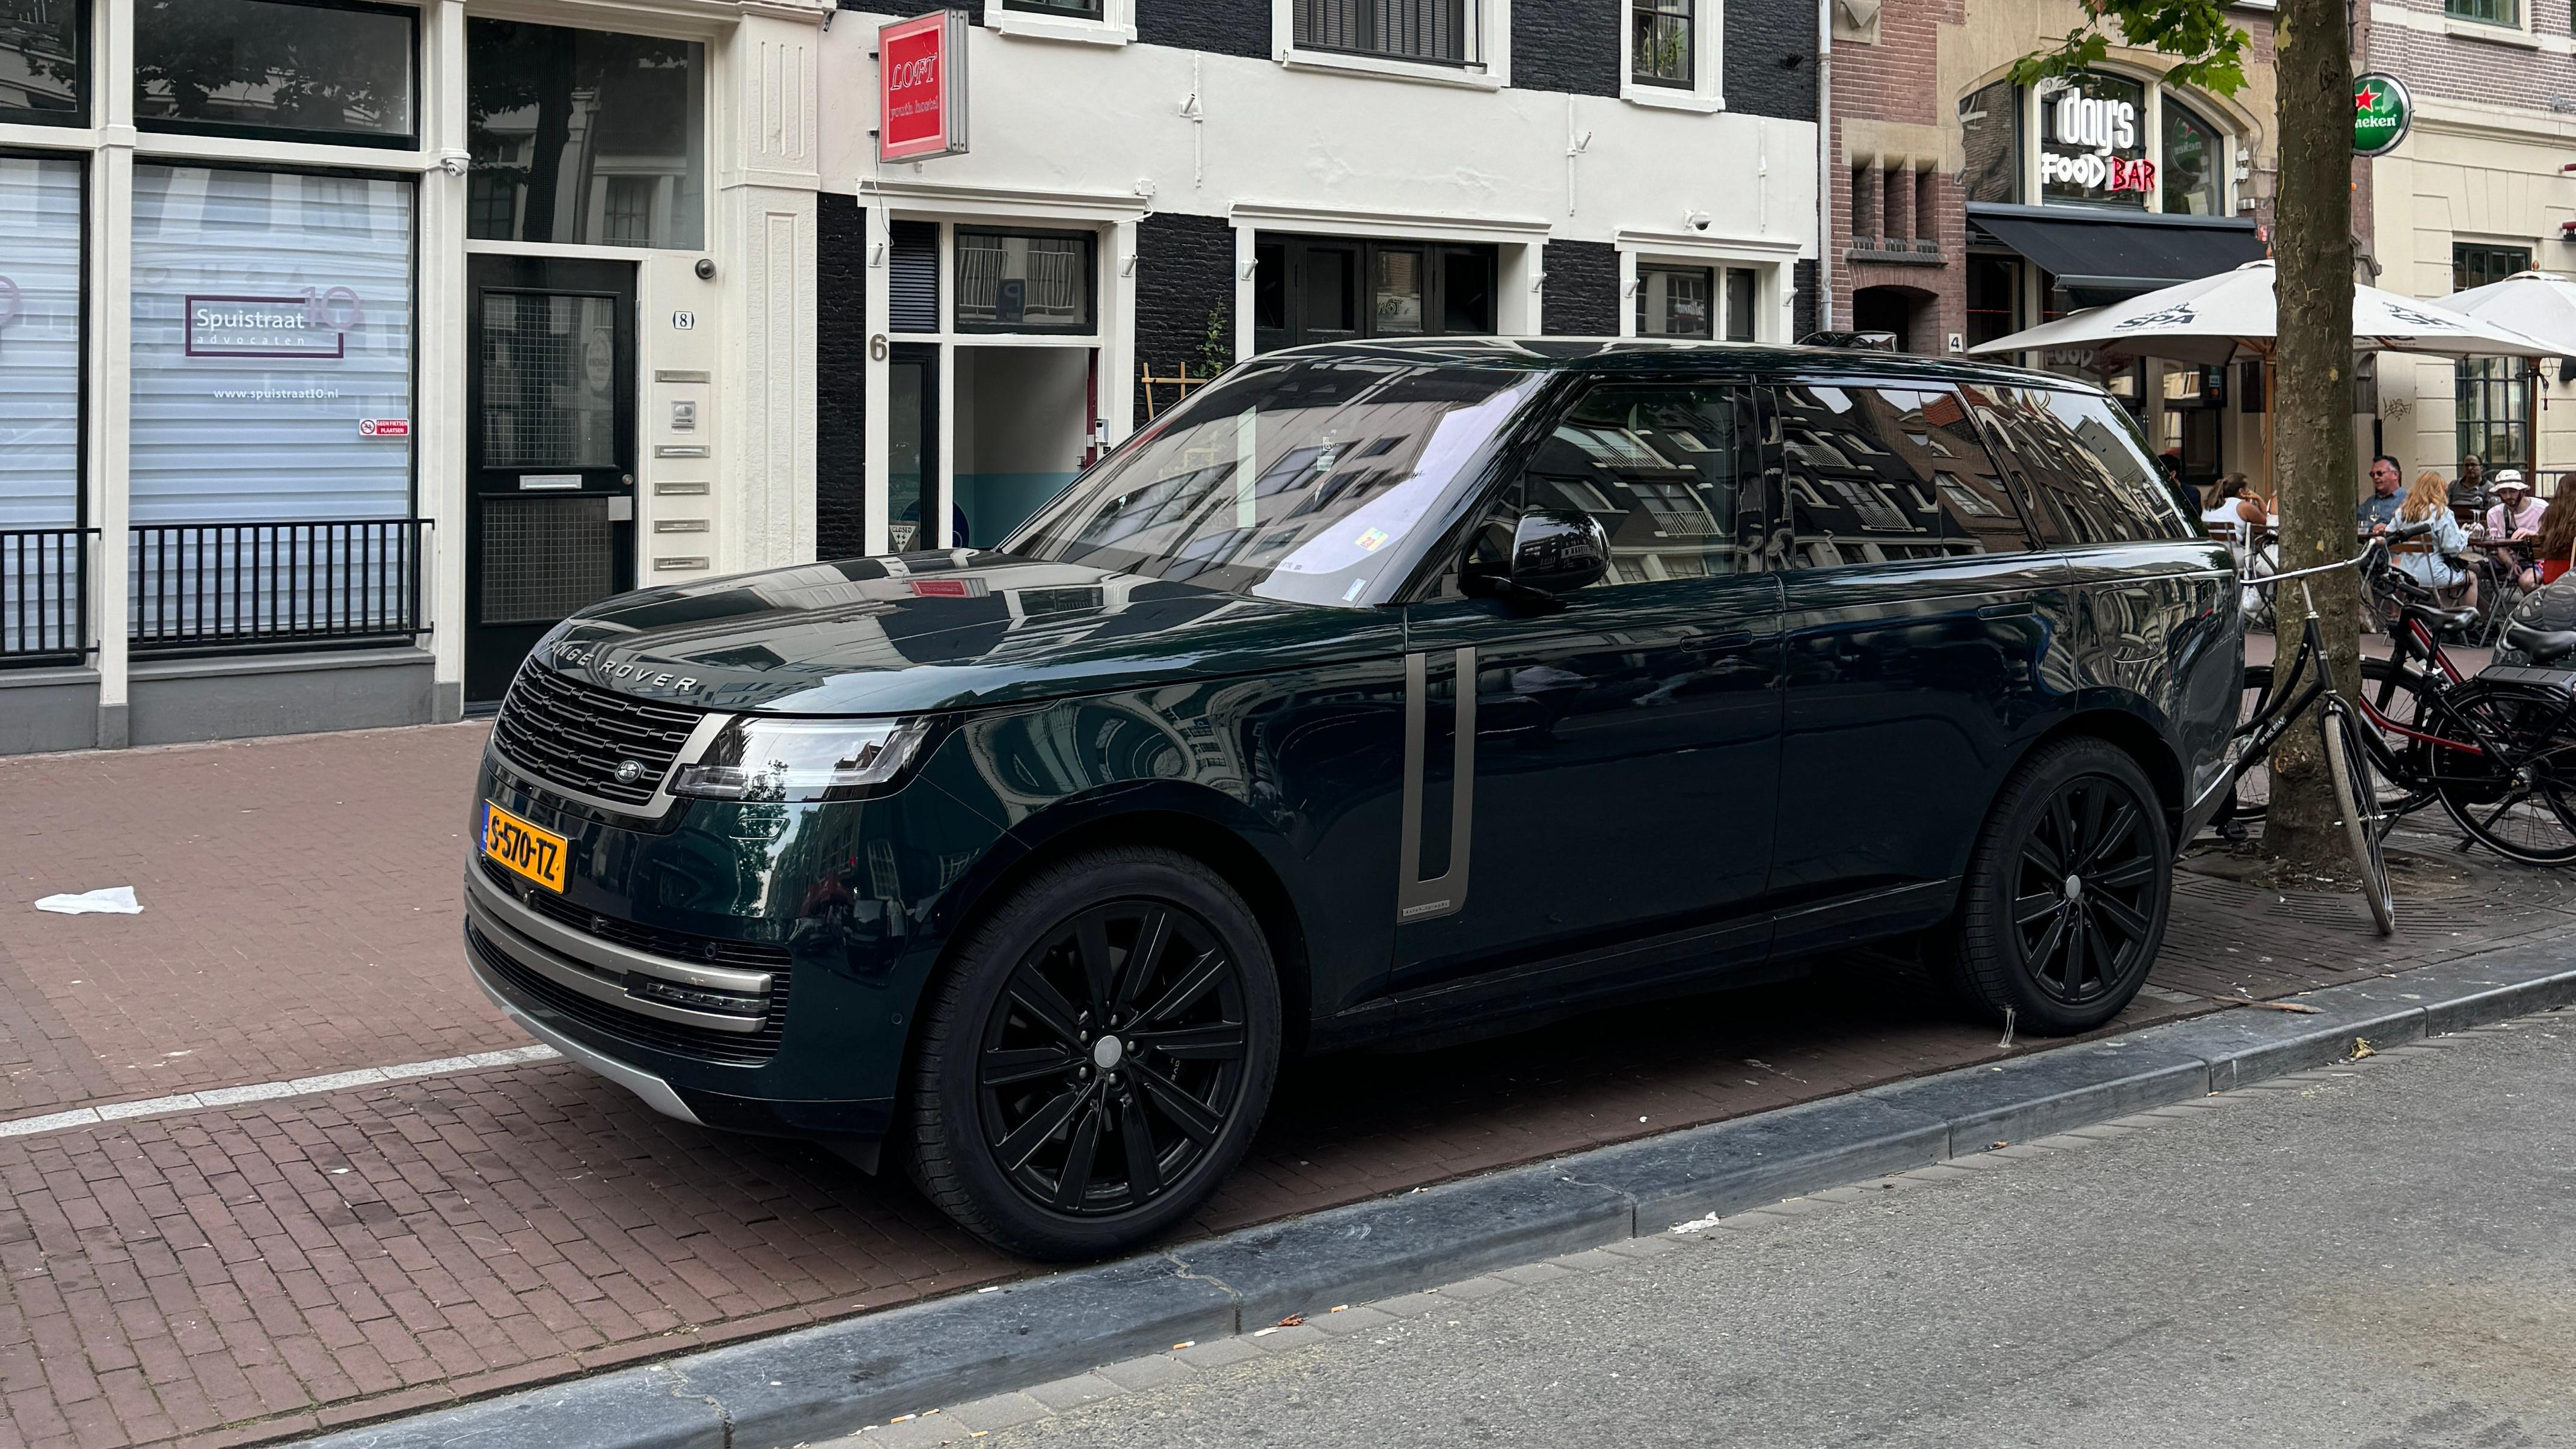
2432;681;2576;866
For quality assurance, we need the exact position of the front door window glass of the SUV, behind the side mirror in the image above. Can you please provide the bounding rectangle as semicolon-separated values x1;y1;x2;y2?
1514;384;1762;588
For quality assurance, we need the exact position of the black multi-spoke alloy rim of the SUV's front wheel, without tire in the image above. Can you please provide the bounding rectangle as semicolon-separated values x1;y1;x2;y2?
977;900;1250;1214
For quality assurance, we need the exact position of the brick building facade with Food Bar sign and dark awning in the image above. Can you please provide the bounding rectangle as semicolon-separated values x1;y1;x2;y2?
1826;0;2287;475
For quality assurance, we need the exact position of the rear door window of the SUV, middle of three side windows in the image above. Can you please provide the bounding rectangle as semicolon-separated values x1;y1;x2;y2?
1780;381;2030;567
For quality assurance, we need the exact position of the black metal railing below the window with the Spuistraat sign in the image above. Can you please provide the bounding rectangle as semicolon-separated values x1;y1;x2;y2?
126;518;428;650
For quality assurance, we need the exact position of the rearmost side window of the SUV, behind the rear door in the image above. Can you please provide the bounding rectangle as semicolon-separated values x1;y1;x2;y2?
1968;387;2200;544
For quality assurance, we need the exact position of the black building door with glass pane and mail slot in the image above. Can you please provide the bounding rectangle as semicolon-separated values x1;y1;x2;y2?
466;255;636;704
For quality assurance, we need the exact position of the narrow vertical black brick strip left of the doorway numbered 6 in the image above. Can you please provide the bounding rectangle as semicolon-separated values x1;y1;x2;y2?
814;191;868;559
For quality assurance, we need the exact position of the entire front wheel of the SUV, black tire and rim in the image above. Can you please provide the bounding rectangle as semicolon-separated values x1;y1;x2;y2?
909;846;1280;1258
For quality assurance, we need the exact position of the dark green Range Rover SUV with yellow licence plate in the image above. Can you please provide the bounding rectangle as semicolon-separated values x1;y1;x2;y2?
466;340;2243;1256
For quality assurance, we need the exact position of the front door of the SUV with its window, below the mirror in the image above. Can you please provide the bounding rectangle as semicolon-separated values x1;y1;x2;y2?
1396;381;1780;1011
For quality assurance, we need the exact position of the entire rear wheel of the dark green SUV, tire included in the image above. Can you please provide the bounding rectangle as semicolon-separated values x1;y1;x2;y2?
1942;737;2174;1036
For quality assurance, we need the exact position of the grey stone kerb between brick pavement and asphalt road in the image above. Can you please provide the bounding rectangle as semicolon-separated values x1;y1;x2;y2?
287;946;2576;1449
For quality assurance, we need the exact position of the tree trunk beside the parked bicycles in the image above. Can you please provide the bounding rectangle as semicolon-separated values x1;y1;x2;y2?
2265;0;2362;866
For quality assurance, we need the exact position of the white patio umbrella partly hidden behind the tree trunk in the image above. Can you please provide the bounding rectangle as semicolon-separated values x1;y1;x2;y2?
1968;260;2568;366
